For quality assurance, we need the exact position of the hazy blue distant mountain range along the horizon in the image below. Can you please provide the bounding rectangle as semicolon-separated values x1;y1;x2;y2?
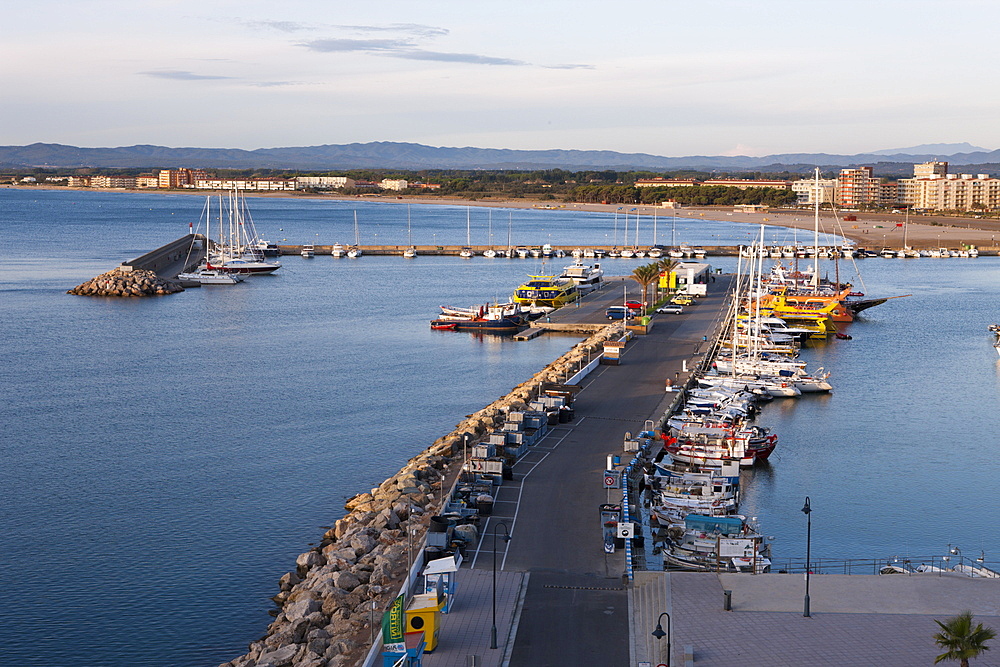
0;141;1000;175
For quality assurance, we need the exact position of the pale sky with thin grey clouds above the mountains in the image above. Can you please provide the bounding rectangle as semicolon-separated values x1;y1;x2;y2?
0;0;1000;156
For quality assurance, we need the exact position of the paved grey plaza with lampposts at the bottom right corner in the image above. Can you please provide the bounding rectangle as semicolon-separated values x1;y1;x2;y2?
629;572;1000;667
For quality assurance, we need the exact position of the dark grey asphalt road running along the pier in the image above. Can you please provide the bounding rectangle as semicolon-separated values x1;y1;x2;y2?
468;274;729;667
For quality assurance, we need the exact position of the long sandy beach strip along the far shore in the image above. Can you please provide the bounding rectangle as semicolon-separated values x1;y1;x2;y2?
3;185;1000;251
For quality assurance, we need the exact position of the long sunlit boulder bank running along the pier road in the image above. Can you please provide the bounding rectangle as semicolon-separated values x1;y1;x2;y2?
220;324;622;667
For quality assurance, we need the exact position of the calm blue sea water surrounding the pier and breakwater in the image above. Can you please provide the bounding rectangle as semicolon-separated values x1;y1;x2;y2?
0;189;1000;667
